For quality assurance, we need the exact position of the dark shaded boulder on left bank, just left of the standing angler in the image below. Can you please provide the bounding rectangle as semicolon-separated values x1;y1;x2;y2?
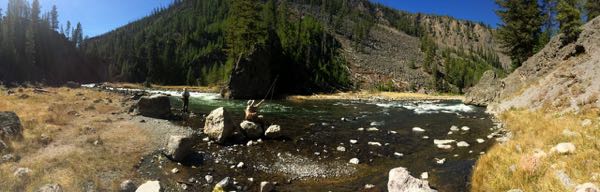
137;94;171;119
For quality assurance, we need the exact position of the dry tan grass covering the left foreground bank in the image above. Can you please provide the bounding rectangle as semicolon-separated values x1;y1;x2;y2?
0;88;149;191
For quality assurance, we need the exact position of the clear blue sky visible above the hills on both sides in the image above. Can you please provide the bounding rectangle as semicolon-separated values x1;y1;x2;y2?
0;0;499;37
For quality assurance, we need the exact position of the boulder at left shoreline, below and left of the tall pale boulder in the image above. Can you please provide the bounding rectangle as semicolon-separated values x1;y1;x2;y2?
164;135;197;162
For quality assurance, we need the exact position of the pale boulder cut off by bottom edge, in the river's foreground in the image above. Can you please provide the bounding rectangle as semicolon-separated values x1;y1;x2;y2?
388;167;437;192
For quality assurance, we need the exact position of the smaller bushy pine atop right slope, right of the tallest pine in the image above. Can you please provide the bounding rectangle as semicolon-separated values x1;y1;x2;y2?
557;0;581;44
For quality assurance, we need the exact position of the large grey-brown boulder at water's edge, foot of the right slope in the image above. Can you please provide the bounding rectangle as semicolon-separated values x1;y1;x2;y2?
465;70;502;106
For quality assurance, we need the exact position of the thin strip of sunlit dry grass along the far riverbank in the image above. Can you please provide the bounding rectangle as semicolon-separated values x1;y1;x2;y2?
288;91;464;100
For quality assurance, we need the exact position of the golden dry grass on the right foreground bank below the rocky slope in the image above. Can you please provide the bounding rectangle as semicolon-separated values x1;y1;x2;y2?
472;110;600;191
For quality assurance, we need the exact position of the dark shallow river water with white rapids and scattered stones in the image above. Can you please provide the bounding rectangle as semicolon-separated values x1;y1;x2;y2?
90;86;495;191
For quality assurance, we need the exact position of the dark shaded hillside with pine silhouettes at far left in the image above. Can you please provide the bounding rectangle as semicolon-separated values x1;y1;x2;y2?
0;0;106;84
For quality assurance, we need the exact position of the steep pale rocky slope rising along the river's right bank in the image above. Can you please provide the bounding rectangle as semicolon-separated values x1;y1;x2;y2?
466;17;600;113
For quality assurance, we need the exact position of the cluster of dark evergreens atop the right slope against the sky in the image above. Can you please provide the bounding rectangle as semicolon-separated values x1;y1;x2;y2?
496;0;600;69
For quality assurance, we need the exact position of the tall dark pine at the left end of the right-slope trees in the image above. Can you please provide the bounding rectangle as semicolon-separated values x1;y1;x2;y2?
496;0;543;69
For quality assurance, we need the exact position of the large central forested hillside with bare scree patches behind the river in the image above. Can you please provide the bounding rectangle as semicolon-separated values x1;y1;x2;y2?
84;0;507;95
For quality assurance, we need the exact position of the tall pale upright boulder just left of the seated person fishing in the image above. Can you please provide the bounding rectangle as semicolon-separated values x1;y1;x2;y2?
204;107;234;143
